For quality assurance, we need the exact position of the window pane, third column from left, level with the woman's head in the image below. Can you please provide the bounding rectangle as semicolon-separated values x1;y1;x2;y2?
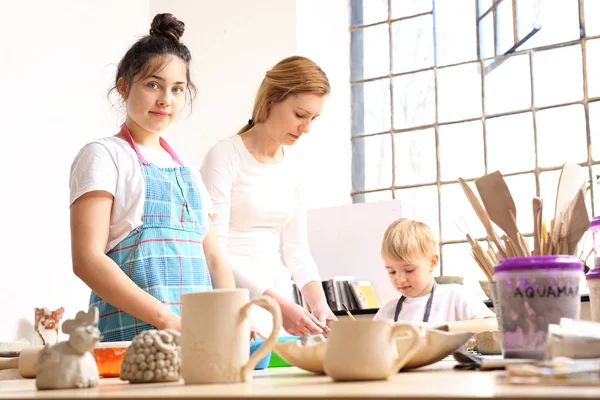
438;63;481;122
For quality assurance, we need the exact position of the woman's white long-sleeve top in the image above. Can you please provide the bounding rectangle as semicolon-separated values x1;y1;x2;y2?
200;135;320;298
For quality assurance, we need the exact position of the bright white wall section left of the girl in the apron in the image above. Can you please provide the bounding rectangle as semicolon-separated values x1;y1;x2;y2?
0;0;148;341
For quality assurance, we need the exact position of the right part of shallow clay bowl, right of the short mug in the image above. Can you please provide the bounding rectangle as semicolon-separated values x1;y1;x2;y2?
396;327;473;370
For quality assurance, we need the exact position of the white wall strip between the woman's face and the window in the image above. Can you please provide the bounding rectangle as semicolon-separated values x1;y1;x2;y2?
296;0;352;208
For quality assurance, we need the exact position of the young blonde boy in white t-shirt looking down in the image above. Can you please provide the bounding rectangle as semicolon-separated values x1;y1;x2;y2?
374;218;498;333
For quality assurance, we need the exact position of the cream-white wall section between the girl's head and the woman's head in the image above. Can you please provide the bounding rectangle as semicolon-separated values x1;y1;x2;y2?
150;0;296;167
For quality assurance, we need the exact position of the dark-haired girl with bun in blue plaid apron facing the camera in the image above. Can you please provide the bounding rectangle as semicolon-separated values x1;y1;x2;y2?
70;14;235;341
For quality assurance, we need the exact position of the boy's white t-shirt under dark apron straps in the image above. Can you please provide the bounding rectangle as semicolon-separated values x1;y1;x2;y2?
373;284;495;322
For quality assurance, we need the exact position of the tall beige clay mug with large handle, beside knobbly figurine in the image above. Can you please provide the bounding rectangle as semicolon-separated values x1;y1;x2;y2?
181;289;281;384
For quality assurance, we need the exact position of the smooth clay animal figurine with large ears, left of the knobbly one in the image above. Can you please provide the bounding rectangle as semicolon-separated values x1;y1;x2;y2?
35;307;100;389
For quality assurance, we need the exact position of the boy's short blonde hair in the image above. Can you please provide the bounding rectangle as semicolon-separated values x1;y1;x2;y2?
381;218;438;263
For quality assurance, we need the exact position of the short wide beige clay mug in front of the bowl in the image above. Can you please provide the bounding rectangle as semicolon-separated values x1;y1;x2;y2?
324;320;422;381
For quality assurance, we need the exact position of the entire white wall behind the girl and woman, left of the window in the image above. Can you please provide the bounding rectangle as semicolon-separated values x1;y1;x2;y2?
0;0;350;341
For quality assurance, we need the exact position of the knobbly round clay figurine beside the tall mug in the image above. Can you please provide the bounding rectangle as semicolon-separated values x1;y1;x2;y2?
120;329;181;383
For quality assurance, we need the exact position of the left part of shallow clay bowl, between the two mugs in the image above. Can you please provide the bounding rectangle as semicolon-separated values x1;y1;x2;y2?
273;339;327;374
